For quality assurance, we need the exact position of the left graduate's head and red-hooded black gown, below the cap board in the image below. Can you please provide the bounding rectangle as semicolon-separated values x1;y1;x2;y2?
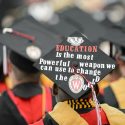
0;51;43;125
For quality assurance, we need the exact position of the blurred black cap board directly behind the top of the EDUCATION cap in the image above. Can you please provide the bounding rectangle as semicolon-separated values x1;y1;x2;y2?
60;7;106;42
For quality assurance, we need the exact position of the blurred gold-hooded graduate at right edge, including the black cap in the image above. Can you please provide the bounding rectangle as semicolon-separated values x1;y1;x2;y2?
104;27;125;109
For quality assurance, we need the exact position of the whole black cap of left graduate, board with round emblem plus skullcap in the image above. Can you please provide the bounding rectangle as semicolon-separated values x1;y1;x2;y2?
0;19;59;72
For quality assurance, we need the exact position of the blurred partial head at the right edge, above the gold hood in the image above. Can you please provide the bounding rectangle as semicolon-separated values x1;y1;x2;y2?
116;47;125;76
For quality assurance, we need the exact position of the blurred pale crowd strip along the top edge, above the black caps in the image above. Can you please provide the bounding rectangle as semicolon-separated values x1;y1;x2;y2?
0;0;125;27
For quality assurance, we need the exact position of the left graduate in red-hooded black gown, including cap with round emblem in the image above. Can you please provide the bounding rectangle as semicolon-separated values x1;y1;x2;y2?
0;20;58;125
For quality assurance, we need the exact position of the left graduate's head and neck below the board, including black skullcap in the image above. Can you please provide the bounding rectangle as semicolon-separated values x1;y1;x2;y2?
8;51;40;83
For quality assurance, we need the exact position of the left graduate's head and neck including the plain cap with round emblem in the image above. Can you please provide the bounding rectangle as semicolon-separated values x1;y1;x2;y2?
0;18;59;86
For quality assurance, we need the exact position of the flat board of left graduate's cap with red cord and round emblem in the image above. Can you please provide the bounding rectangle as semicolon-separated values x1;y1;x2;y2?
0;19;60;62
